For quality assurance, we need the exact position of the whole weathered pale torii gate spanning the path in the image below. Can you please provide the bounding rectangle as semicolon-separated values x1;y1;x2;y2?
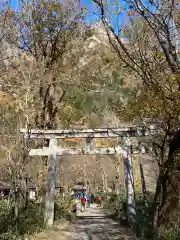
20;127;152;227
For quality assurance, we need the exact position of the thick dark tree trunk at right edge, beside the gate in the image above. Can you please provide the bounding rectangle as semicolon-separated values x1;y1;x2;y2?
153;131;180;232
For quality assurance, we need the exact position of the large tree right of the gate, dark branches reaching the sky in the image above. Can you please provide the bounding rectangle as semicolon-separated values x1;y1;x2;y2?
93;0;180;232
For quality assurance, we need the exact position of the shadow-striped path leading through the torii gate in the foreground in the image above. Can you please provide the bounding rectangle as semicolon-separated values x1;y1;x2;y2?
33;205;136;240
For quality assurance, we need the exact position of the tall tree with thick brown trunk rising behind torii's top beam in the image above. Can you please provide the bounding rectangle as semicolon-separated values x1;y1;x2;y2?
15;0;83;128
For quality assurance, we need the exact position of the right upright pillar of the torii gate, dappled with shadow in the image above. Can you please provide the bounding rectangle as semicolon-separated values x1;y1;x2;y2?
123;138;136;222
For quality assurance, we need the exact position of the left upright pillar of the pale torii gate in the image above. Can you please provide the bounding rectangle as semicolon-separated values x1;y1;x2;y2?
44;138;57;227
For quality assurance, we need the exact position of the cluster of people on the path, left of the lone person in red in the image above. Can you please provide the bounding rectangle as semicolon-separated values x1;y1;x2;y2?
72;190;92;212
